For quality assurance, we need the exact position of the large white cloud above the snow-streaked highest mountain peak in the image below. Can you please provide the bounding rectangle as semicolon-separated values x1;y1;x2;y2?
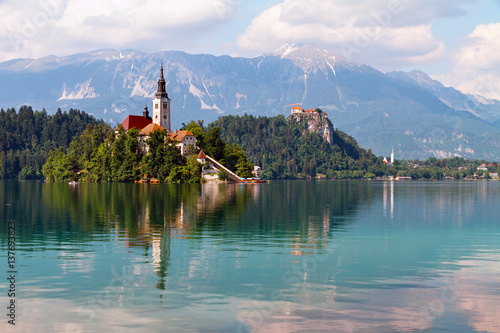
237;0;474;69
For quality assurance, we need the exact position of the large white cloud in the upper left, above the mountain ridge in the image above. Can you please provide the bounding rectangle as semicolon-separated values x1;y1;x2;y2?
0;0;238;60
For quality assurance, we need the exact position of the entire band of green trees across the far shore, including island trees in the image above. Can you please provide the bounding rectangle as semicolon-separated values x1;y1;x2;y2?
0;106;500;183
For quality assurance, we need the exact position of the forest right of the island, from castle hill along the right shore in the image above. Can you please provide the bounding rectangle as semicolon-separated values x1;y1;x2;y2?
208;115;500;180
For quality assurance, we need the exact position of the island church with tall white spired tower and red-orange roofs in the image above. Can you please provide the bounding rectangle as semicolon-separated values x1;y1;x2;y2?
115;64;196;155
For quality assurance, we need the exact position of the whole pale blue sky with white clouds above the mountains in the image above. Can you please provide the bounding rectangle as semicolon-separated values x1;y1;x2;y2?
0;0;500;99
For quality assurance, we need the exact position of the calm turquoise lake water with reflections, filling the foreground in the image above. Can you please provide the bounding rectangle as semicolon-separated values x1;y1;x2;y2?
0;181;500;333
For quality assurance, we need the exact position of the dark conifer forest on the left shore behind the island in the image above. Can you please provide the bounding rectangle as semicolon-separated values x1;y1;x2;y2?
0;106;107;179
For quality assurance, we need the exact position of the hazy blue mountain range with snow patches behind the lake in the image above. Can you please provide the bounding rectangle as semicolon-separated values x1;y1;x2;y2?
0;44;500;160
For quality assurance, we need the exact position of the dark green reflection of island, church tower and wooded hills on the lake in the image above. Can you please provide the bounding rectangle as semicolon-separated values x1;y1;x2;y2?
0;182;373;289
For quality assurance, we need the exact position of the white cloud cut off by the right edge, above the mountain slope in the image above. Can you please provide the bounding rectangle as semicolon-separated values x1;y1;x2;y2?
434;23;500;99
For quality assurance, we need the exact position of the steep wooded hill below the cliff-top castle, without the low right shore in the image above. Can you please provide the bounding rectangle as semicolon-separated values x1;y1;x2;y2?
209;115;388;179
